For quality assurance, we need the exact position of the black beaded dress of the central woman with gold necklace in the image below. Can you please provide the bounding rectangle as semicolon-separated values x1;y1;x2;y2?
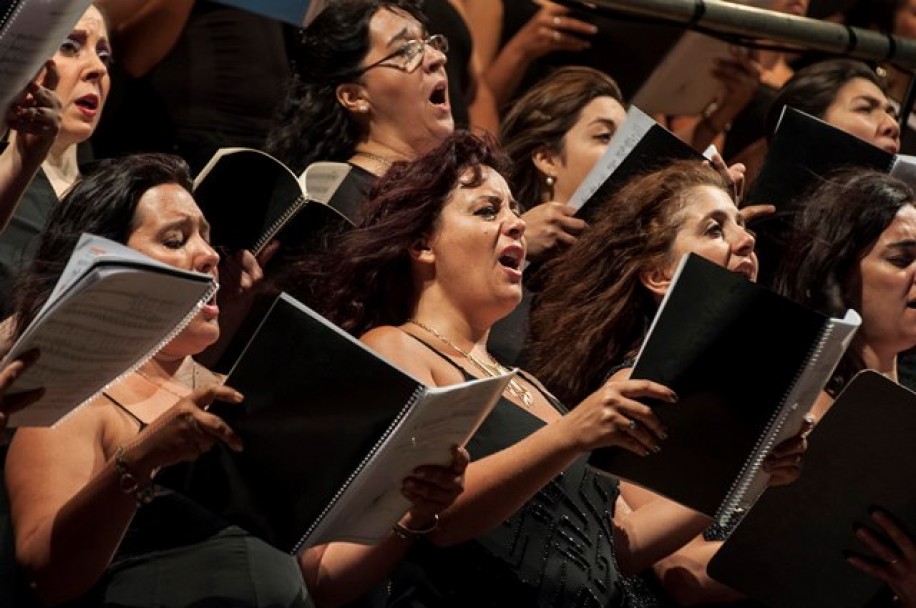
377;338;631;608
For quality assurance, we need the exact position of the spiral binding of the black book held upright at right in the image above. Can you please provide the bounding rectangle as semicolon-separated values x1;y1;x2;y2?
715;323;832;527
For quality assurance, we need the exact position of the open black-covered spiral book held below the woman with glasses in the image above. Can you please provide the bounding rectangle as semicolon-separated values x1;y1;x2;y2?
194;148;352;255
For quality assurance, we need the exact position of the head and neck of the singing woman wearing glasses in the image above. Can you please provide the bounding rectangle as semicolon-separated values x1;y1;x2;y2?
267;0;454;219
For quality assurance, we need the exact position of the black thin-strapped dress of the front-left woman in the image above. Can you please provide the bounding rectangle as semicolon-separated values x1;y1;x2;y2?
65;397;312;608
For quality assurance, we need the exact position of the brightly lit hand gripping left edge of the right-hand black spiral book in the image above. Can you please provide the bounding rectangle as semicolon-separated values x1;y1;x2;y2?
565;379;677;456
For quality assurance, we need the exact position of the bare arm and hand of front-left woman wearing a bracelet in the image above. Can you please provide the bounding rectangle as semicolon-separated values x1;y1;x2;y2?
5;386;241;603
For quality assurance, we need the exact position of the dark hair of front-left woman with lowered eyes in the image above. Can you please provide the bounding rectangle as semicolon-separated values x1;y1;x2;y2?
15;153;191;336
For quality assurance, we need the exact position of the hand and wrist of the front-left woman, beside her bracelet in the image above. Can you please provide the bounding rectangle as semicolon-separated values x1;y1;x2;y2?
124;385;249;478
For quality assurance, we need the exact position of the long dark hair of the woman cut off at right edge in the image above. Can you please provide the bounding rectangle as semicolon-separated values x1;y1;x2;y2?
773;168;916;393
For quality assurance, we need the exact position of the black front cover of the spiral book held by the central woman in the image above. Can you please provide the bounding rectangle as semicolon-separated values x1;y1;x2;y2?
157;296;419;551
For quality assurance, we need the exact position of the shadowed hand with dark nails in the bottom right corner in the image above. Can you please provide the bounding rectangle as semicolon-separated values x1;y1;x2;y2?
846;508;916;608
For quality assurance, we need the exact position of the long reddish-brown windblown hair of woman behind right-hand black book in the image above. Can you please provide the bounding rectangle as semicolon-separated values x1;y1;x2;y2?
528;161;728;404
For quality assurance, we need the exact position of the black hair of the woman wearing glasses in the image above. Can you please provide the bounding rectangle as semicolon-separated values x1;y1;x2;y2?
265;0;426;174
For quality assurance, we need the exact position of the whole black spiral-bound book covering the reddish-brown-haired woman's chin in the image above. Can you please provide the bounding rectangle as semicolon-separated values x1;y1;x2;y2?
590;254;861;524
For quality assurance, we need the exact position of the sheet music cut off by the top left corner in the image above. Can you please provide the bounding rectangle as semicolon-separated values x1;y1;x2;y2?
0;0;91;123
